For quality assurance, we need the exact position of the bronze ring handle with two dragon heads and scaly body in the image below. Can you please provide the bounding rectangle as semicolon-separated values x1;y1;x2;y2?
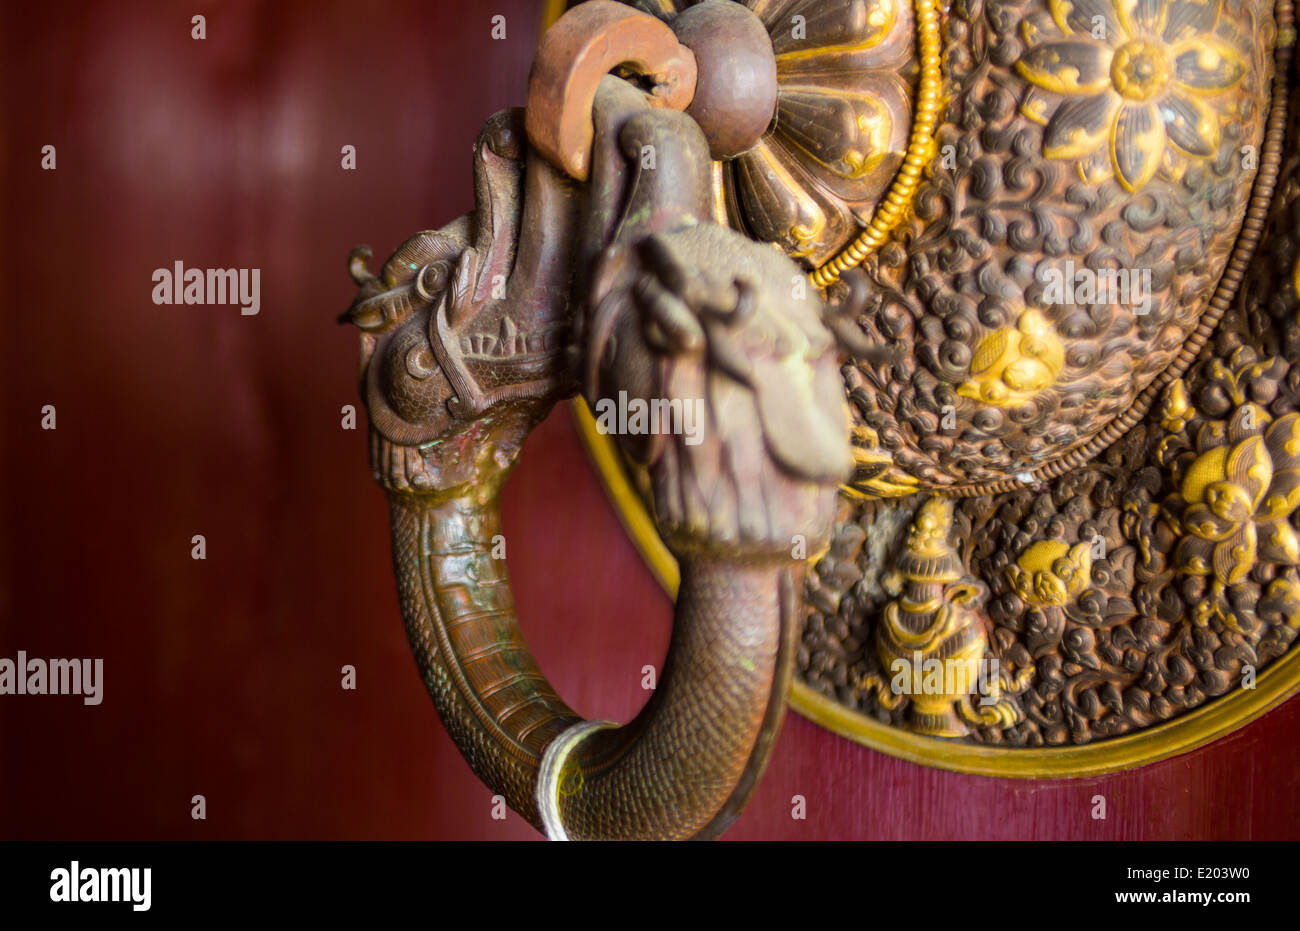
345;85;853;839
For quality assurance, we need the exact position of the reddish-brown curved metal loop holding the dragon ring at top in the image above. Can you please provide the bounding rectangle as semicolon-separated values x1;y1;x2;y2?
527;0;696;181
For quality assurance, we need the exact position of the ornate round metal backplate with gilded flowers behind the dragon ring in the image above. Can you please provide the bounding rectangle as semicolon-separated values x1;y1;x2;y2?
577;0;1300;776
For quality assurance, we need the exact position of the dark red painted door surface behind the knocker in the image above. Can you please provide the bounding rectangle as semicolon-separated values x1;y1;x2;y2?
0;0;1300;839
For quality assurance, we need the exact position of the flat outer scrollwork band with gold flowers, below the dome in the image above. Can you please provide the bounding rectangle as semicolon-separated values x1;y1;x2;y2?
800;41;1300;749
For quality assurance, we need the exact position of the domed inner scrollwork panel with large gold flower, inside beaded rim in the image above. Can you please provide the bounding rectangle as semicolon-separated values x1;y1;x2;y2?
832;0;1275;494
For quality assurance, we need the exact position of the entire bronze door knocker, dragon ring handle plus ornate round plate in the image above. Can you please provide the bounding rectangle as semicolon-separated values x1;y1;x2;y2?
343;0;1300;839
